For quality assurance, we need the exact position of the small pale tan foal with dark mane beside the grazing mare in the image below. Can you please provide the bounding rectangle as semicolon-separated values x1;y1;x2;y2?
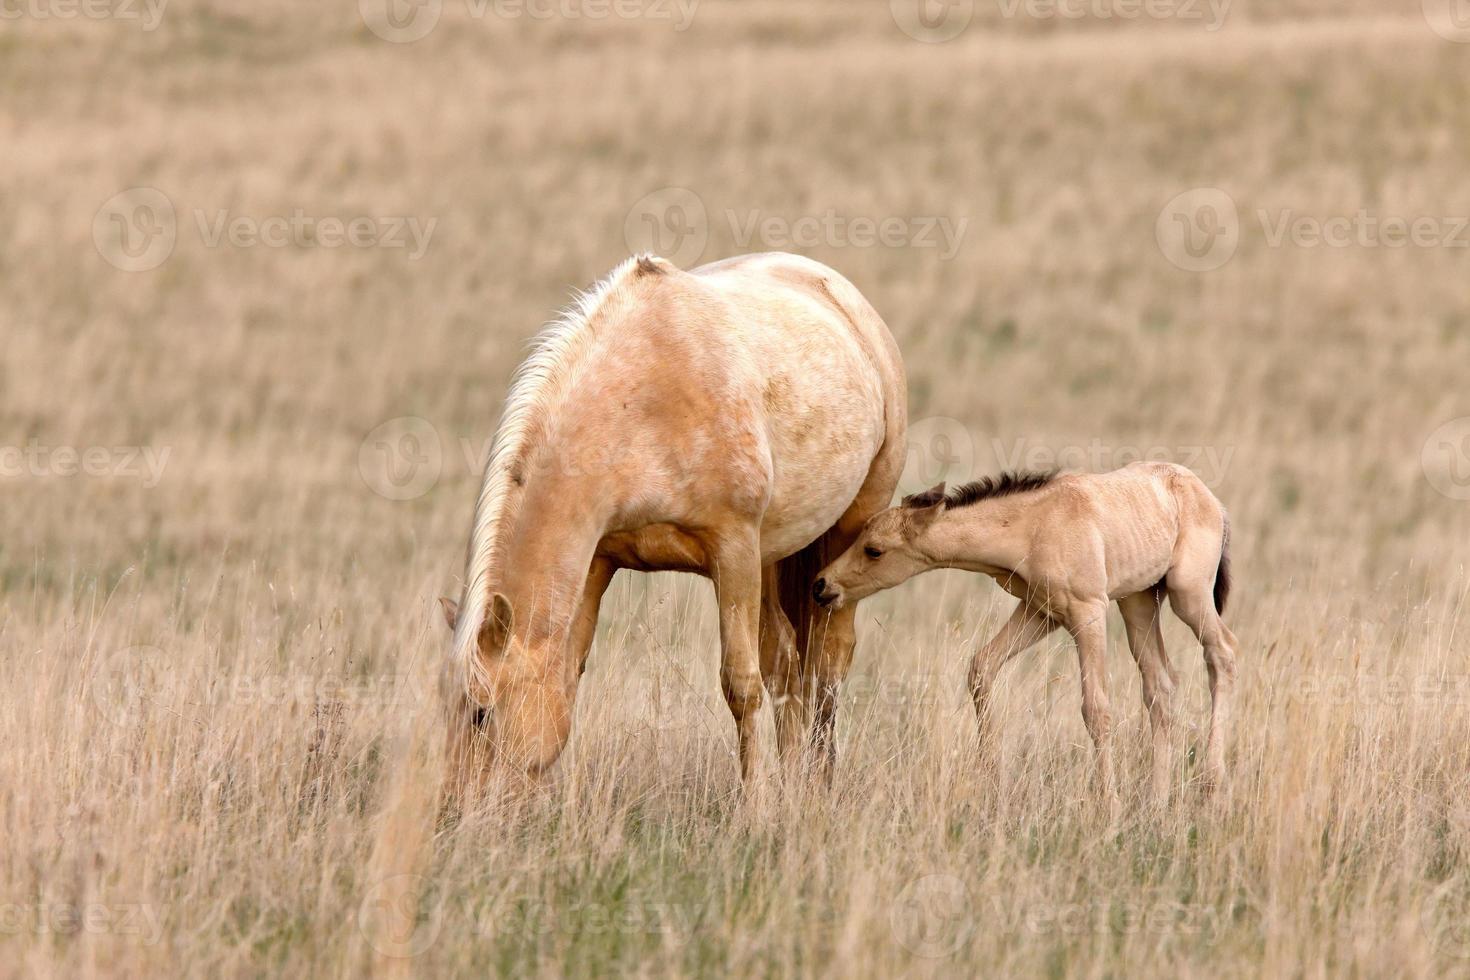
813;461;1235;802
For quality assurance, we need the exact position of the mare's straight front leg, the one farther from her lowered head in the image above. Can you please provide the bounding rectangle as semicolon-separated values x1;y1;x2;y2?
710;527;763;785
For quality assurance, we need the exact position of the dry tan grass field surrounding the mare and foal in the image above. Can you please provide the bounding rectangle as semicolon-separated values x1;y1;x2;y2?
0;0;1470;977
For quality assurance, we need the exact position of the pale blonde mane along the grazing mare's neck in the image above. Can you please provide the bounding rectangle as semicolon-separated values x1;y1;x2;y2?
451;256;669;683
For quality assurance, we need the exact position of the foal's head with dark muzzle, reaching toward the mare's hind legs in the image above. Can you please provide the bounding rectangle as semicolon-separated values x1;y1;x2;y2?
811;483;945;610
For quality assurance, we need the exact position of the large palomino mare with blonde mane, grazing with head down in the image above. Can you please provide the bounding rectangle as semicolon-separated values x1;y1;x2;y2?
444;253;907;780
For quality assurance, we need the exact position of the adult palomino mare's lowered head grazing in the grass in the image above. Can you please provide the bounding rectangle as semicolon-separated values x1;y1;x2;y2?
440;592;572;786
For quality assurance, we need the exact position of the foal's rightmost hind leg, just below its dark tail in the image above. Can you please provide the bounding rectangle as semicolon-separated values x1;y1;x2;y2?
1167;530;1236;786
